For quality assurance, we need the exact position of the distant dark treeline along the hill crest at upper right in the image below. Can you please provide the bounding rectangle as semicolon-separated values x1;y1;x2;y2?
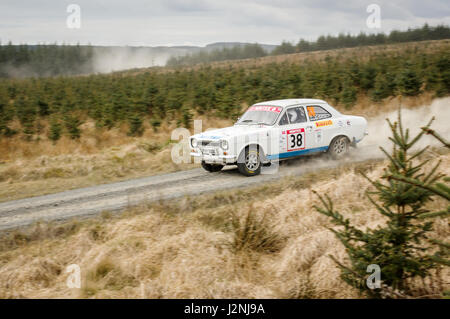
166;24;450;66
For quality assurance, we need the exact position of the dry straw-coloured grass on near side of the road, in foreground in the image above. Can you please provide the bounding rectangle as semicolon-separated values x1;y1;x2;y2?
0;152;450;298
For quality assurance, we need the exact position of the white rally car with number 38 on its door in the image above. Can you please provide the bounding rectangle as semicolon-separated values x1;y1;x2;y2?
189;99;367;176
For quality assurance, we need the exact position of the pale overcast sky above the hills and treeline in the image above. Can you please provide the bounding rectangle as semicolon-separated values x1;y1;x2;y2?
0;0;450;46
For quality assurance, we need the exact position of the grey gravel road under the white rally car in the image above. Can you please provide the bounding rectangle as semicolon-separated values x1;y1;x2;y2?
0;151;372;231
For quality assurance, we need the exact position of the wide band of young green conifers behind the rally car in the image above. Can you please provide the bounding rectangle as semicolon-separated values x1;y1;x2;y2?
0;43;450;140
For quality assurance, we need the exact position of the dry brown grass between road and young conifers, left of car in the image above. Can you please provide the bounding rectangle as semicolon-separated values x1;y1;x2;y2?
0;116;231;201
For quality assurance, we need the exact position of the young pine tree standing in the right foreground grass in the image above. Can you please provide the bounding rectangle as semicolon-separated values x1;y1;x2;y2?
315;112;449;297
